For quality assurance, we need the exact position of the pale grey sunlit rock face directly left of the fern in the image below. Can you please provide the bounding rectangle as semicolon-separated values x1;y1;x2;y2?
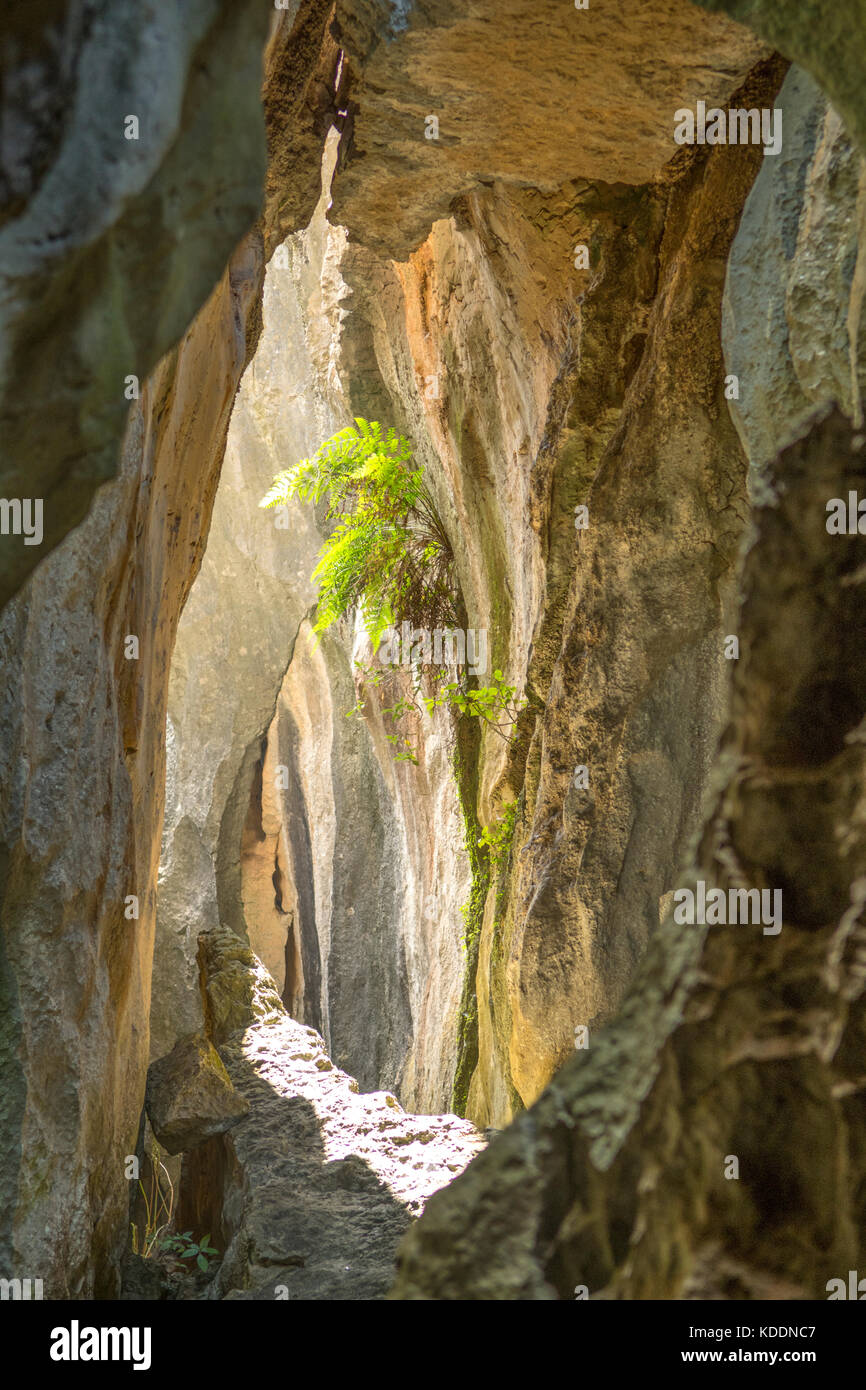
152;149;342;1056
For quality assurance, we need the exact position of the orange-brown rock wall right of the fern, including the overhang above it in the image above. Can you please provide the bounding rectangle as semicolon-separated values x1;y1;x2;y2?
318;0;784;1125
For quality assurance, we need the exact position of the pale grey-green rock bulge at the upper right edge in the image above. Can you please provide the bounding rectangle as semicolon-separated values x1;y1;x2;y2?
723;68;866;495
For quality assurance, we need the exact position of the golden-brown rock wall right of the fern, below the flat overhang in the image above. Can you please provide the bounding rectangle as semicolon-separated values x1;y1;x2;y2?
330;51;784;1126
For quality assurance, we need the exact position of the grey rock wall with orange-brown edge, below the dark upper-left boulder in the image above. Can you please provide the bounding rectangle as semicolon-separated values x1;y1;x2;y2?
0;238;261;1298
